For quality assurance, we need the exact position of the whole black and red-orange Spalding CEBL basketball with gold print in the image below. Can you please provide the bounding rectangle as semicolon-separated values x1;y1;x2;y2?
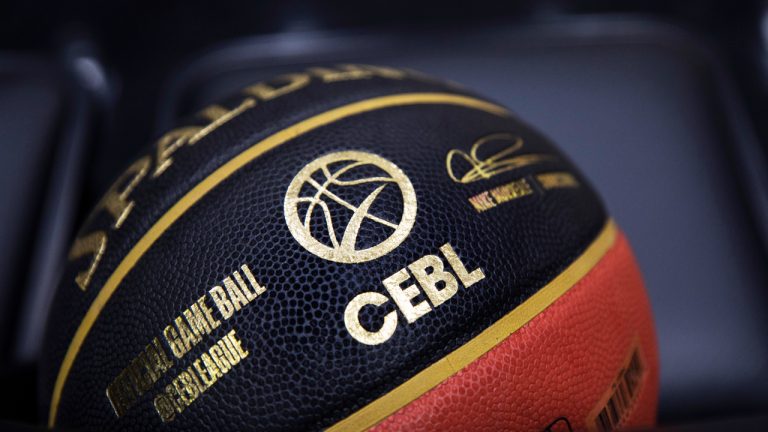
40;64;659;431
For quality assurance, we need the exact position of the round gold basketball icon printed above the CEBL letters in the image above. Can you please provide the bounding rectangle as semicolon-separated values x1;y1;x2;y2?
284;151;416;263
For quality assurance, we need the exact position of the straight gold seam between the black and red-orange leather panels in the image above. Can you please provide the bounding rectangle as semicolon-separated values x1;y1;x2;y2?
326;219;616;432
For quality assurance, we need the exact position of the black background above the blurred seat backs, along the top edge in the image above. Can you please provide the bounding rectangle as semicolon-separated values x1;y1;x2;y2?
6;0;768;228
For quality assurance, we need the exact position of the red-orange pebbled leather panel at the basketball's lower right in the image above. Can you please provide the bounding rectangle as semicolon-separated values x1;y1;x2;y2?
373;234;659;431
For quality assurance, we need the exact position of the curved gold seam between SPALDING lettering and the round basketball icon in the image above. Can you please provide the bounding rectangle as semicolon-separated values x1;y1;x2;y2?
48;93;511;427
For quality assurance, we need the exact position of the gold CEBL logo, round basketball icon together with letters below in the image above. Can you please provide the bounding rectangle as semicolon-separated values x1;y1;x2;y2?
284;151;485;345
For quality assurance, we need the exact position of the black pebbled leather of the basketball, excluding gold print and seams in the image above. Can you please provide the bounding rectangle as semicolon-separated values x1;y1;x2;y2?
41;66;656;431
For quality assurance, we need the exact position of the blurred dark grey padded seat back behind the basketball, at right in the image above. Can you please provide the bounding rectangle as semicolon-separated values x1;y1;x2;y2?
158;21;768;421
